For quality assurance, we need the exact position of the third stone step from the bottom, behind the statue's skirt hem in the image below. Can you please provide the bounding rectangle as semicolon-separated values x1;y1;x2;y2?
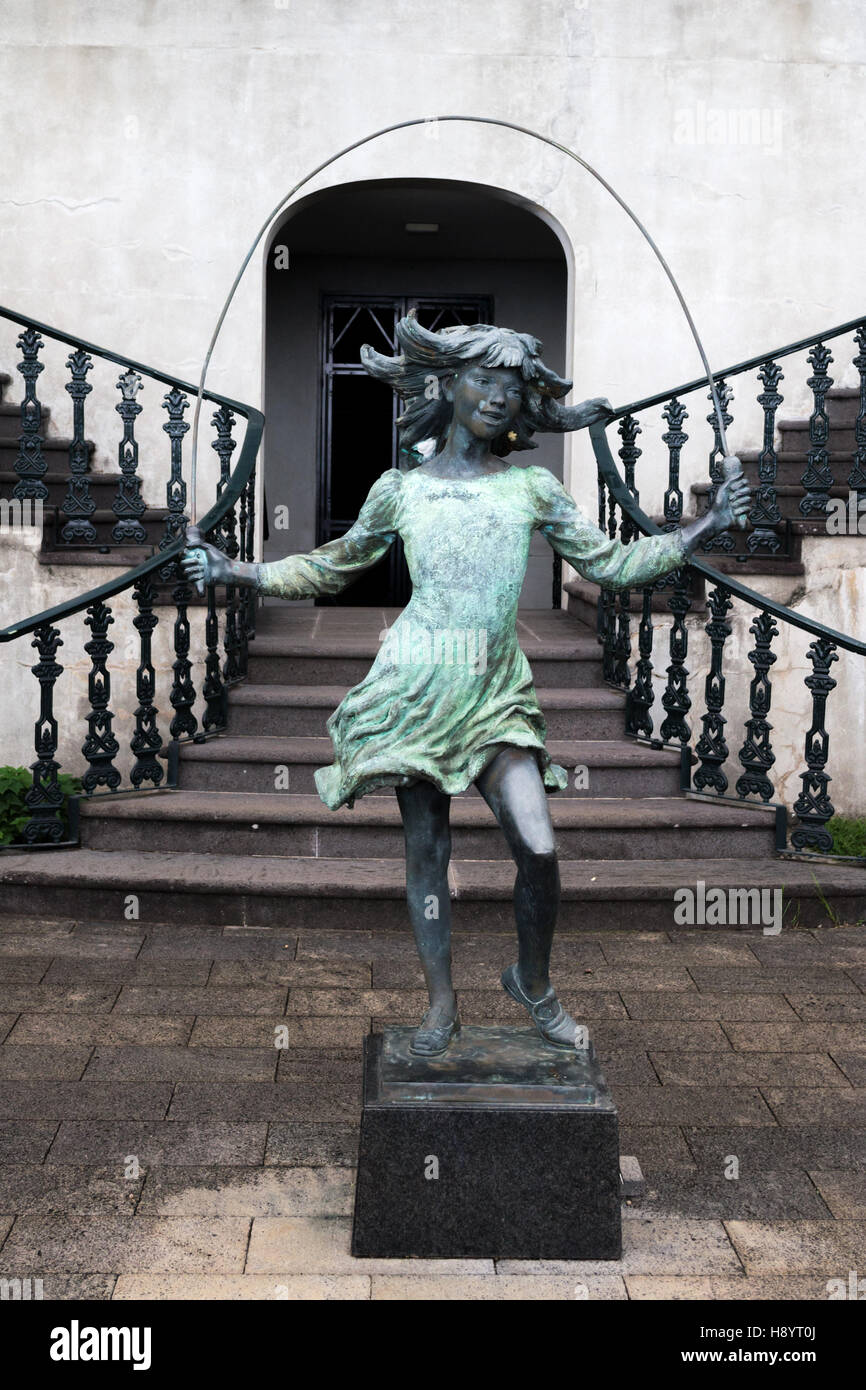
169;734;680;796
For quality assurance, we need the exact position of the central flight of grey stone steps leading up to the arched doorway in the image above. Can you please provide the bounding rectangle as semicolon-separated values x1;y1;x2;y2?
0;603;866;931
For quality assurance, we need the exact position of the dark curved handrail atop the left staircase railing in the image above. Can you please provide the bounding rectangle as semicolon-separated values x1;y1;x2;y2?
0;306;264;642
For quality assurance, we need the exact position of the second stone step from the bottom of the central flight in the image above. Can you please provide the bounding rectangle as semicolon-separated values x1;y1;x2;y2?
81;791;774;859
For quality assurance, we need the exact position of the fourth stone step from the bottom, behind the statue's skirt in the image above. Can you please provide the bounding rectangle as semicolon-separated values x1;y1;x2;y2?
223;681;626;739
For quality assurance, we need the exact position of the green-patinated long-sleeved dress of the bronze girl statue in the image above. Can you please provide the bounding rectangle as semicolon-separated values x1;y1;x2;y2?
259;464;685;809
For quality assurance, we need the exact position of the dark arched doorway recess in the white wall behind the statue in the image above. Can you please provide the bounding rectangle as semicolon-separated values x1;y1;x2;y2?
263;179;569;607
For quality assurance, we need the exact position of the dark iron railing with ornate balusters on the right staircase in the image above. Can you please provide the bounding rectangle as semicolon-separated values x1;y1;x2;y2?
589;318;866;853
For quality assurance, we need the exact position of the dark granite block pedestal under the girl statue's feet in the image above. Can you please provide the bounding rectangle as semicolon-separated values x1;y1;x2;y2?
352;1027;621;1259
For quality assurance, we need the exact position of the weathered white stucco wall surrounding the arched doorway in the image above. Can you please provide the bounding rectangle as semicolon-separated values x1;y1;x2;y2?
0;0;866;811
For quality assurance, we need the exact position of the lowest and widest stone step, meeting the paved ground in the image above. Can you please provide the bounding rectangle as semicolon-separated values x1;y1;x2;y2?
0;849;866;933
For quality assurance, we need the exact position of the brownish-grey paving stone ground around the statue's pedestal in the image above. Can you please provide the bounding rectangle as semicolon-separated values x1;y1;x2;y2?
0;917;866;1300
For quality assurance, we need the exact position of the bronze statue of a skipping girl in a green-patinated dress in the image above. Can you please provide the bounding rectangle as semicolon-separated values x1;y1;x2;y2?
182;314;749;1056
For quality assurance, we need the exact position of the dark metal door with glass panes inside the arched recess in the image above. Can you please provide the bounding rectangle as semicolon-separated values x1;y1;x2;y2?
317;295;493;607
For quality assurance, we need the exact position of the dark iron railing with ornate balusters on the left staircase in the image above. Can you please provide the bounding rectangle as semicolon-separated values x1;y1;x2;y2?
0;309;264;847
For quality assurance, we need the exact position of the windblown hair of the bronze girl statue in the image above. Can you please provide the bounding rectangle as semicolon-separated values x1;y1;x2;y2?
361;310;571;463
